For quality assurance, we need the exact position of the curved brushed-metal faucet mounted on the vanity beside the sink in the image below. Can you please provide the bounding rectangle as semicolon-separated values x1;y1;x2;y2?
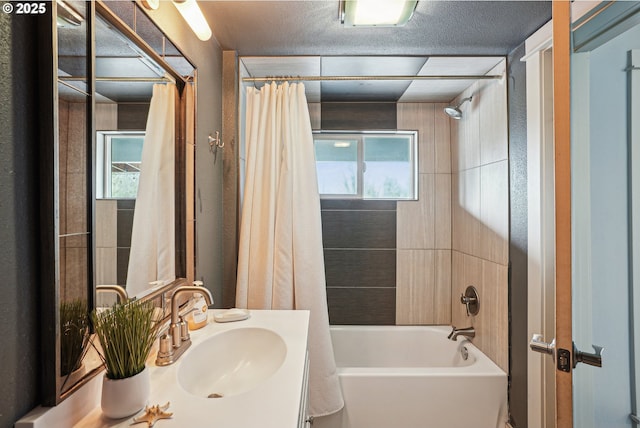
156;285;213;366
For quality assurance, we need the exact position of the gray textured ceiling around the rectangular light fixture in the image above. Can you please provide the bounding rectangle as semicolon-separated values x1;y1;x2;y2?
205;0;551;102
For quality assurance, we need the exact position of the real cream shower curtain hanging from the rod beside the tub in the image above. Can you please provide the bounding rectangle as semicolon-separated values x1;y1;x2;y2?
236;83;343;416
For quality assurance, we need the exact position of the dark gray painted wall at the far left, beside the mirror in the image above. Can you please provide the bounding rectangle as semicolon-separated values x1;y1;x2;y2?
0;13;46;428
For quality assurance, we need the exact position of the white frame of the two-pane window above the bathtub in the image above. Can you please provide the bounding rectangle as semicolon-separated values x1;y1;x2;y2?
312;130;419;201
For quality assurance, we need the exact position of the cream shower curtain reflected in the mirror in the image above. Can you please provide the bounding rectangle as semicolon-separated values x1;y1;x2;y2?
127;83;177;296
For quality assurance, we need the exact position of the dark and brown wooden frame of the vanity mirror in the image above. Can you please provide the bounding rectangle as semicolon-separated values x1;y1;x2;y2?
38;0;197;406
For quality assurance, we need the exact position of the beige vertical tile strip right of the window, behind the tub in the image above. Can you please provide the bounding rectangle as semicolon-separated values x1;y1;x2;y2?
396;103;451;324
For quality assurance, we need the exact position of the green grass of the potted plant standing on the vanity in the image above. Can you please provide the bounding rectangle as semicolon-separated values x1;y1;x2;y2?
91;300;159;379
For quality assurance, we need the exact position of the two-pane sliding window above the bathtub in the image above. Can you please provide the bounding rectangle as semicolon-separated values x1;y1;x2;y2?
313;131;417;199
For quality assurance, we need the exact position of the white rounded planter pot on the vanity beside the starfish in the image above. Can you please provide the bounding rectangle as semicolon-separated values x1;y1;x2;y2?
100;367;151;419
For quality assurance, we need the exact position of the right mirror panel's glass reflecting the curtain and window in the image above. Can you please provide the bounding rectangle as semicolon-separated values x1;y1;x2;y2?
95;2;194;306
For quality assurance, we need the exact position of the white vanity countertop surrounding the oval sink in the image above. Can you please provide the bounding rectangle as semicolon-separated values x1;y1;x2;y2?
15;309;311;428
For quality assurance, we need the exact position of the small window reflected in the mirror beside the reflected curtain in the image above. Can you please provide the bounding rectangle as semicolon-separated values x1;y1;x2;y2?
96;131;144;199
